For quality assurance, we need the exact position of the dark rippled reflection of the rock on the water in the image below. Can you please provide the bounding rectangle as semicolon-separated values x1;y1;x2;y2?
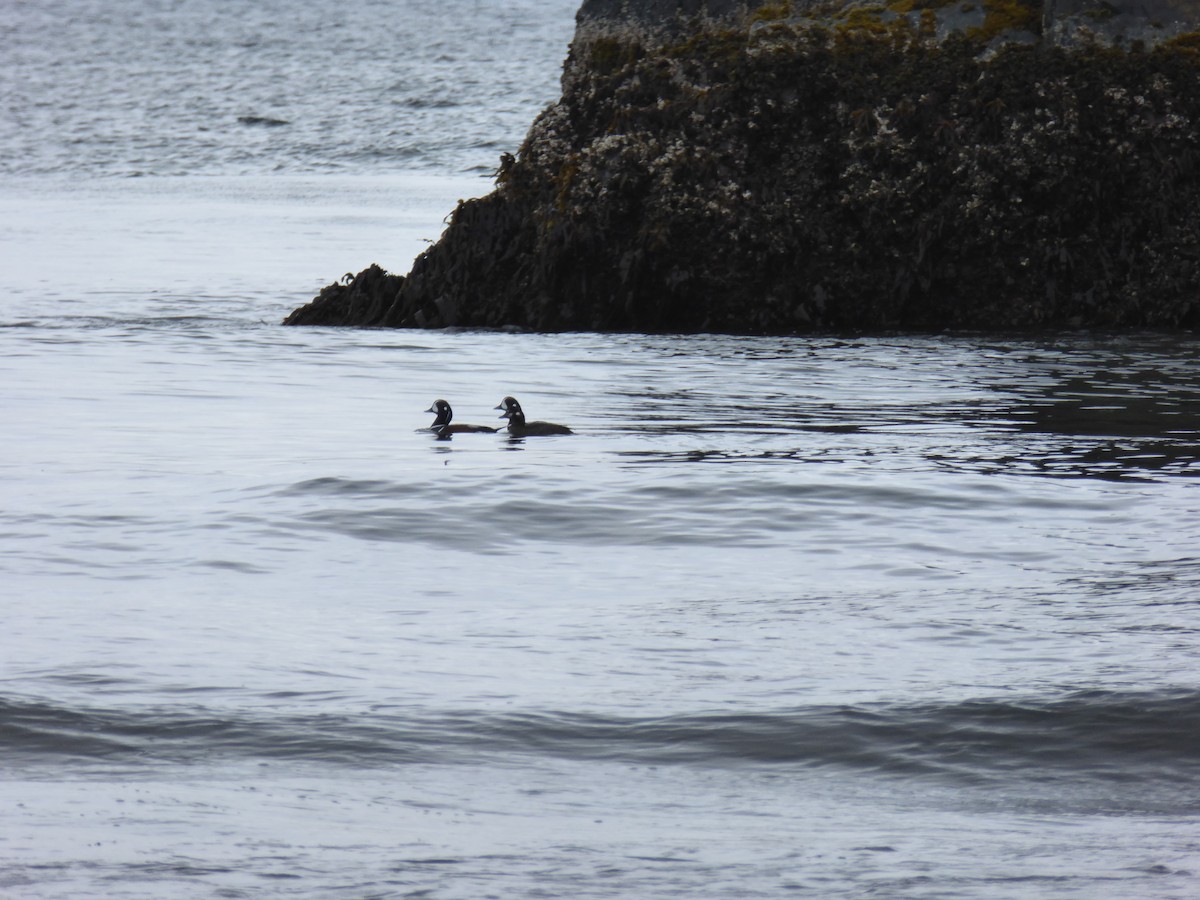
602;335;1200;481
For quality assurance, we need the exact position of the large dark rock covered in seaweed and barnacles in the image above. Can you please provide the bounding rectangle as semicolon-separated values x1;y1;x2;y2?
286;0;1200;332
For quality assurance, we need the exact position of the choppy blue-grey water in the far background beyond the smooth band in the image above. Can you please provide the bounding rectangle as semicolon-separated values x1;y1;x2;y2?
0;0;577;178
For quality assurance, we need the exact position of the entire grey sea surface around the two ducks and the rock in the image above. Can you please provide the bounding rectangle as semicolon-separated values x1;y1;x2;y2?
0;0;1200;900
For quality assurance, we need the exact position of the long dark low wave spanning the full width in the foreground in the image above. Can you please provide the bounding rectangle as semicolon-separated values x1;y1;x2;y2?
0;690;1200;785
